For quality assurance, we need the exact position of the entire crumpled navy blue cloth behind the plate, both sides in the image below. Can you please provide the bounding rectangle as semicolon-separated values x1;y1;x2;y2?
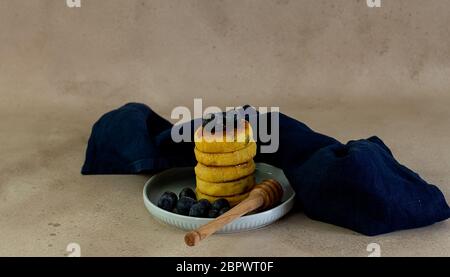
82;103;450;235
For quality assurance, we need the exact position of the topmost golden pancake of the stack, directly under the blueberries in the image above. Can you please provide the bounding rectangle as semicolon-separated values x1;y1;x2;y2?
194;120;254;153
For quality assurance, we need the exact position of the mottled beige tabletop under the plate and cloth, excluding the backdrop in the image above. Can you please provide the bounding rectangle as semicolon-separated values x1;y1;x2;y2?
0;96;450;256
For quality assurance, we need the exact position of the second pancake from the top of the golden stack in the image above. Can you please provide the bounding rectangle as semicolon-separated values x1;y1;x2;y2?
194;141;256;166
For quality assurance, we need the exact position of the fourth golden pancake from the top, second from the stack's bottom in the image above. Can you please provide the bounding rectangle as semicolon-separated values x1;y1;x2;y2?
197;174;255;197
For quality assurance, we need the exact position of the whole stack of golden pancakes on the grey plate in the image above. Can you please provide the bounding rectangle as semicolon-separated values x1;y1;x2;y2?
194;119;256;206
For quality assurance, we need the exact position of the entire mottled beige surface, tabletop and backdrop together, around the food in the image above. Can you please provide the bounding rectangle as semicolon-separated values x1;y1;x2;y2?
0;0;450;256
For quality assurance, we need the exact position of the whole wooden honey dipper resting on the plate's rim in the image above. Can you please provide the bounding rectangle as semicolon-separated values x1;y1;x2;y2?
184;179;283;246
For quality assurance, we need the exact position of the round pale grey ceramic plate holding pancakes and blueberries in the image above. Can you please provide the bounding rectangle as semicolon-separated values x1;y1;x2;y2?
144;163;295;233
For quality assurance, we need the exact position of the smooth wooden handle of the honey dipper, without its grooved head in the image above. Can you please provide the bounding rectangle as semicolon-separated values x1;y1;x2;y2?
184;191;264;246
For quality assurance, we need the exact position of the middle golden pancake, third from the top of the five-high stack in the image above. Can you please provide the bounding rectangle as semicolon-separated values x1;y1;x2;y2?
195;160;255;183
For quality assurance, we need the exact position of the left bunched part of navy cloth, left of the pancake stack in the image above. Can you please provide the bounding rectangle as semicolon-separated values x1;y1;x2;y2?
82;103;195;174
